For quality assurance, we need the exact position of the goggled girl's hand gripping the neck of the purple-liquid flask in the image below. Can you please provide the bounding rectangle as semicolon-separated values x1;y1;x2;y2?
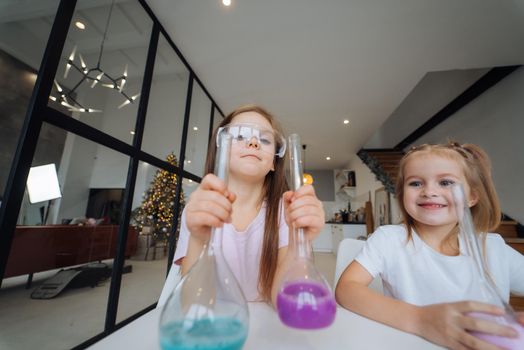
283;185;325;240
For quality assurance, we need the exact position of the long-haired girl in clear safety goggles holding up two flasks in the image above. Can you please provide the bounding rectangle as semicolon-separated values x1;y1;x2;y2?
174;106;324;302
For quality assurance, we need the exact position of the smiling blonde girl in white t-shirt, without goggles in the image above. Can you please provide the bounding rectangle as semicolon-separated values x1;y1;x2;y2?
336;143;524;349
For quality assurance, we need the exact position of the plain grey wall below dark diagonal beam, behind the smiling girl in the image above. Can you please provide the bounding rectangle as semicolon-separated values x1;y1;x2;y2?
416;68;524;222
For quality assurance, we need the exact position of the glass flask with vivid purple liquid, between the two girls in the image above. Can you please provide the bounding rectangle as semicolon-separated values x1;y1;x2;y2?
277;134;336;329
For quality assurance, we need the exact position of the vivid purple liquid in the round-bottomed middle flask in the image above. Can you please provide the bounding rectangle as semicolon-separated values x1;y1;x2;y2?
277;281;337;329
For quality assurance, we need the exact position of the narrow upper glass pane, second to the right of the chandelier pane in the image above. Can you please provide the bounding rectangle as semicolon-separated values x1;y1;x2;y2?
184;81;211;176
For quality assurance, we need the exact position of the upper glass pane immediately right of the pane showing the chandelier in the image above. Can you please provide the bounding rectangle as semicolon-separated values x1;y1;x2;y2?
142;35;189;159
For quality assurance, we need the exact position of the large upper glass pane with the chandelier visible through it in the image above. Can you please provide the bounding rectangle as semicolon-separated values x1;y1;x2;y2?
49;0;152;143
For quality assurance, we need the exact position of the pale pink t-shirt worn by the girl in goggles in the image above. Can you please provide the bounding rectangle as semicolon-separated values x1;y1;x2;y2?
173;202;289;301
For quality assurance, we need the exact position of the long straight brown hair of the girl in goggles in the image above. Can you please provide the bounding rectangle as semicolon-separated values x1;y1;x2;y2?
205;105;288;301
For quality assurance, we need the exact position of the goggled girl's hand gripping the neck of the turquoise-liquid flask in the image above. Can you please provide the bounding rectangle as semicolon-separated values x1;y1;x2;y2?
185;174;236;242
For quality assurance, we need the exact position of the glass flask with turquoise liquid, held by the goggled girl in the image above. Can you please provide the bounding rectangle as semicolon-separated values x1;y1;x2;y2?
159;131;249;350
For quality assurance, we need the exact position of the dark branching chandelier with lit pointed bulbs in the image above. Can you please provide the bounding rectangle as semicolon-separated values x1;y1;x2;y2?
49;0;140;113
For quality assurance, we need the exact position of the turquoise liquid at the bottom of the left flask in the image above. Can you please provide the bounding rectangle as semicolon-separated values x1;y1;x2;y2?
160;318;247;350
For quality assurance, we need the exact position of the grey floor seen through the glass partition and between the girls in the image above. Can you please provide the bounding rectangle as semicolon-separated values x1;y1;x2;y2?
0;252;335;350
